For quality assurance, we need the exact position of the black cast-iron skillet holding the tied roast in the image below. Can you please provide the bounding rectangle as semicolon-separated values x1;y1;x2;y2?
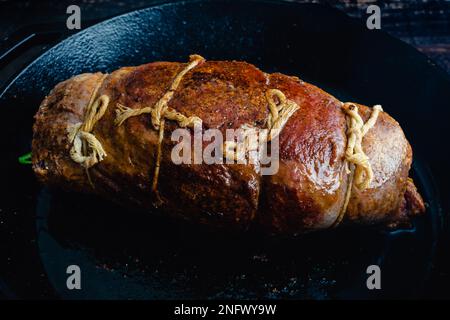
0;1;450;299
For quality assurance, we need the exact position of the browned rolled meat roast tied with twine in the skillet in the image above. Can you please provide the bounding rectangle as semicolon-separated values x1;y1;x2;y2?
32;55;424;235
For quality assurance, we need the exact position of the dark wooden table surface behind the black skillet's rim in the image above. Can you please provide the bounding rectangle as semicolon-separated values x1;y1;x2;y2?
0;0;450;72
